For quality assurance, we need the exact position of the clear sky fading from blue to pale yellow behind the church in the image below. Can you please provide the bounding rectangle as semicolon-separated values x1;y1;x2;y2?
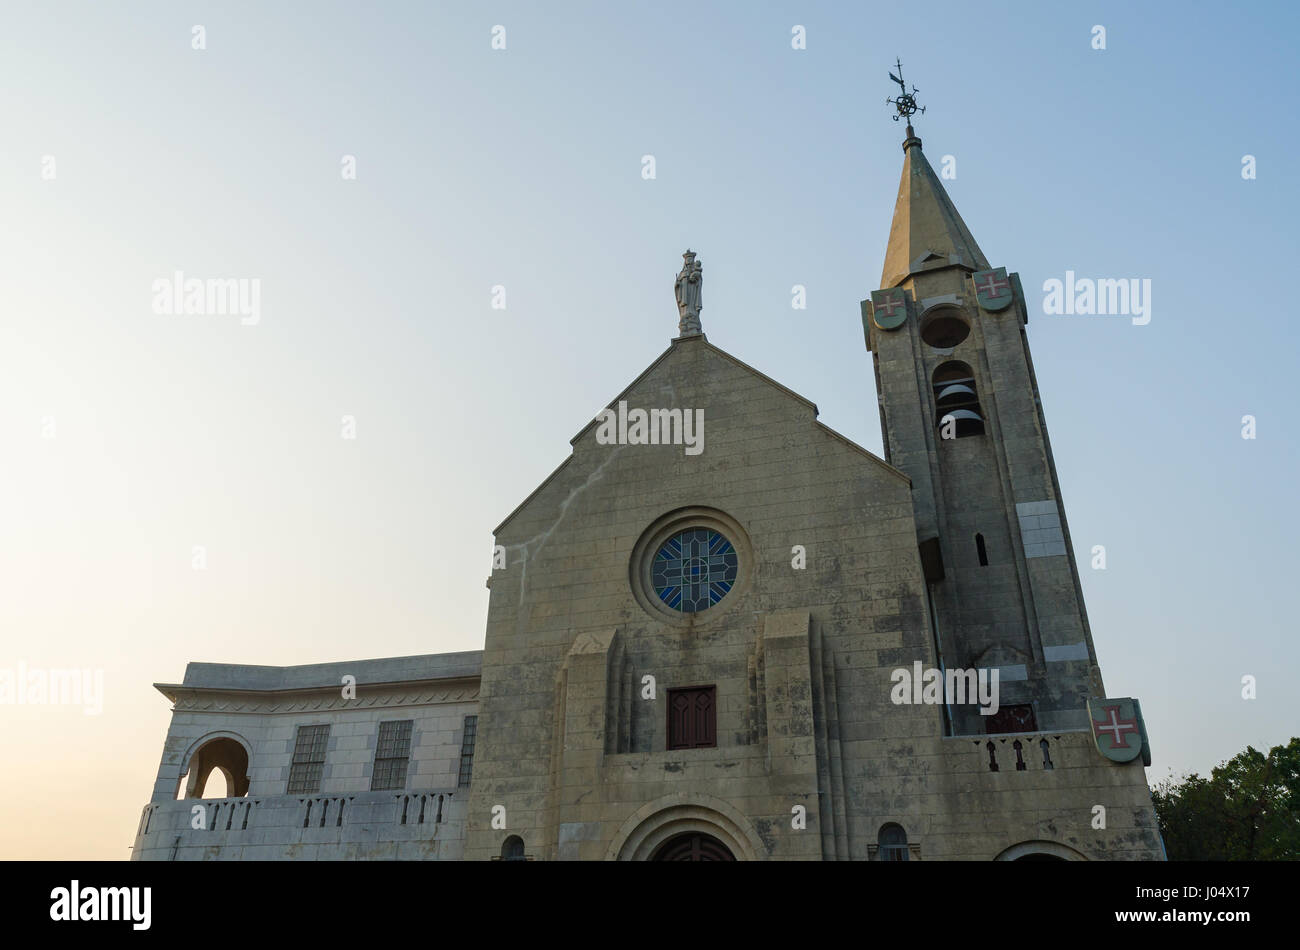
0;0;1300;859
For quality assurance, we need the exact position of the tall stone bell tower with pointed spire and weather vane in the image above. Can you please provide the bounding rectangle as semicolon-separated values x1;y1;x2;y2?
862;77;1105;734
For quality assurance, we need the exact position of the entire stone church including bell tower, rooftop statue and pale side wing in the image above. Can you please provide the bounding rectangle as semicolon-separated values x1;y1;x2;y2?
134;126;1162;860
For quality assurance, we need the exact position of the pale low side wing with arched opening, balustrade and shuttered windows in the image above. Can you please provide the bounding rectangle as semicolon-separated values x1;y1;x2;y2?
133;651;482;860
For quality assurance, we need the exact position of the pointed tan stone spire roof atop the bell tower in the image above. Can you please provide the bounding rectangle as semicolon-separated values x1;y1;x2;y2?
880;123;988;289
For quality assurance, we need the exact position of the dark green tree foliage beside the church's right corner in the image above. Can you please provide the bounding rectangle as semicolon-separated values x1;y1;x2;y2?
1151;738;1300;860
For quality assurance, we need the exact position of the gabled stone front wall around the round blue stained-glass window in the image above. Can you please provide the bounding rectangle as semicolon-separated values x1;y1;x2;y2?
467;338;939;859
